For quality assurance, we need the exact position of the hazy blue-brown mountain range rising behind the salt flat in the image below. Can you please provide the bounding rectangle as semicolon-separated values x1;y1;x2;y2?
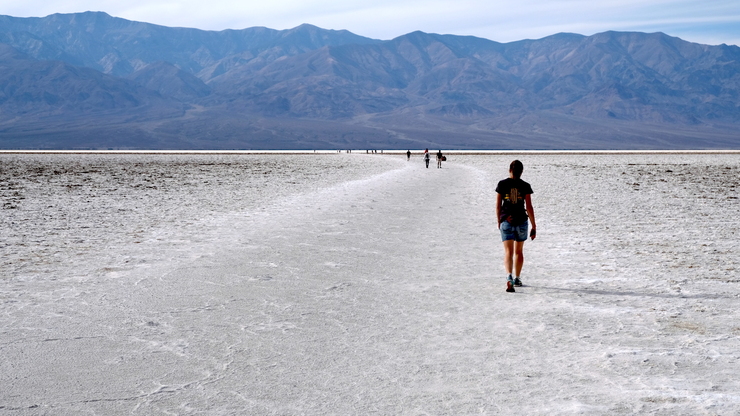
0;12;740;149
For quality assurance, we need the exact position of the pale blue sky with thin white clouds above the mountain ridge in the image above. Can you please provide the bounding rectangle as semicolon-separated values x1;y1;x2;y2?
0;0;740;45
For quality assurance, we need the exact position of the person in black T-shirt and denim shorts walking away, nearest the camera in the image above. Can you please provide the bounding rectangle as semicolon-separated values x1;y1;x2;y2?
496;160;537;292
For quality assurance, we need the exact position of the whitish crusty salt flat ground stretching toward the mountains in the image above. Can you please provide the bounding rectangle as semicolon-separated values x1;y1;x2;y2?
0;155;740;415
